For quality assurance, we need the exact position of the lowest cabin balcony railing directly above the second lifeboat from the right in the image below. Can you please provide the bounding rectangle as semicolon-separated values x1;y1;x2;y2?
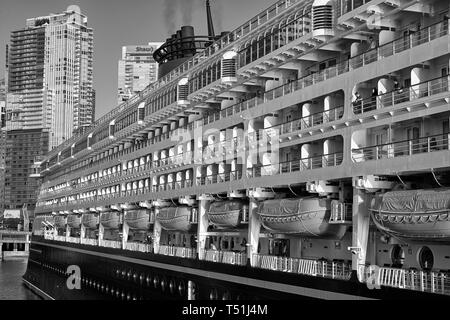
247;152;344;178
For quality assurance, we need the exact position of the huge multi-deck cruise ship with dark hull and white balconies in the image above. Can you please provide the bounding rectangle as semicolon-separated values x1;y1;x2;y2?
23;0;450;300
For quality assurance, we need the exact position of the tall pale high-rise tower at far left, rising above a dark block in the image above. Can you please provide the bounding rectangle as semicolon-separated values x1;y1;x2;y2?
6;6;94;149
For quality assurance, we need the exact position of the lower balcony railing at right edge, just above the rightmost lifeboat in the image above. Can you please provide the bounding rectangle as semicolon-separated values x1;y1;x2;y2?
352;133;450;162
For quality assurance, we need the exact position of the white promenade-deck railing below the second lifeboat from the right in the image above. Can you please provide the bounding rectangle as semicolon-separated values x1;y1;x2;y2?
252;254;352;280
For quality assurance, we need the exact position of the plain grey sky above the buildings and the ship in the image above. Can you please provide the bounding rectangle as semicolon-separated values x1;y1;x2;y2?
0;0;276;118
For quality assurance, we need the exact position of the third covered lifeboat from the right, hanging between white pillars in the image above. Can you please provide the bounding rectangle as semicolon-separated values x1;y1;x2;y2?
208;200;248;228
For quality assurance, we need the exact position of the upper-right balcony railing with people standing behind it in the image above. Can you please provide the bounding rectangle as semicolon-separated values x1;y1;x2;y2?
353;76;450;114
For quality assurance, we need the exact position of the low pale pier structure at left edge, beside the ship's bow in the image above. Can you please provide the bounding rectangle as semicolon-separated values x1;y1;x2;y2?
0;230;31;261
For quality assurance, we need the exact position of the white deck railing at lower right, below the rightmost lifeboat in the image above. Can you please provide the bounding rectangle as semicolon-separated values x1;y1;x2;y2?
361;266;450;295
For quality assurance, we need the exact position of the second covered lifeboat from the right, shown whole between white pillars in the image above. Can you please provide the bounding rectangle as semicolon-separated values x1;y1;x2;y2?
258;197;347;239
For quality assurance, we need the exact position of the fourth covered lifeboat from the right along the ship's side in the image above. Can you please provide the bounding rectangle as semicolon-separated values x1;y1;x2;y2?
156;207;193;232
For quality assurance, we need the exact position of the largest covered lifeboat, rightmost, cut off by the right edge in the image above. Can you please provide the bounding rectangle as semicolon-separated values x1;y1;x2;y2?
370;188;450;241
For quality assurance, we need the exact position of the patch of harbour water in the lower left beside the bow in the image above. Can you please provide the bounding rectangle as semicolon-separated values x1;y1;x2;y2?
0;258;39;300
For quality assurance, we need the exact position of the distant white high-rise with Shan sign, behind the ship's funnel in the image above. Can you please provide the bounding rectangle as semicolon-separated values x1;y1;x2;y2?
117;42;163;104
